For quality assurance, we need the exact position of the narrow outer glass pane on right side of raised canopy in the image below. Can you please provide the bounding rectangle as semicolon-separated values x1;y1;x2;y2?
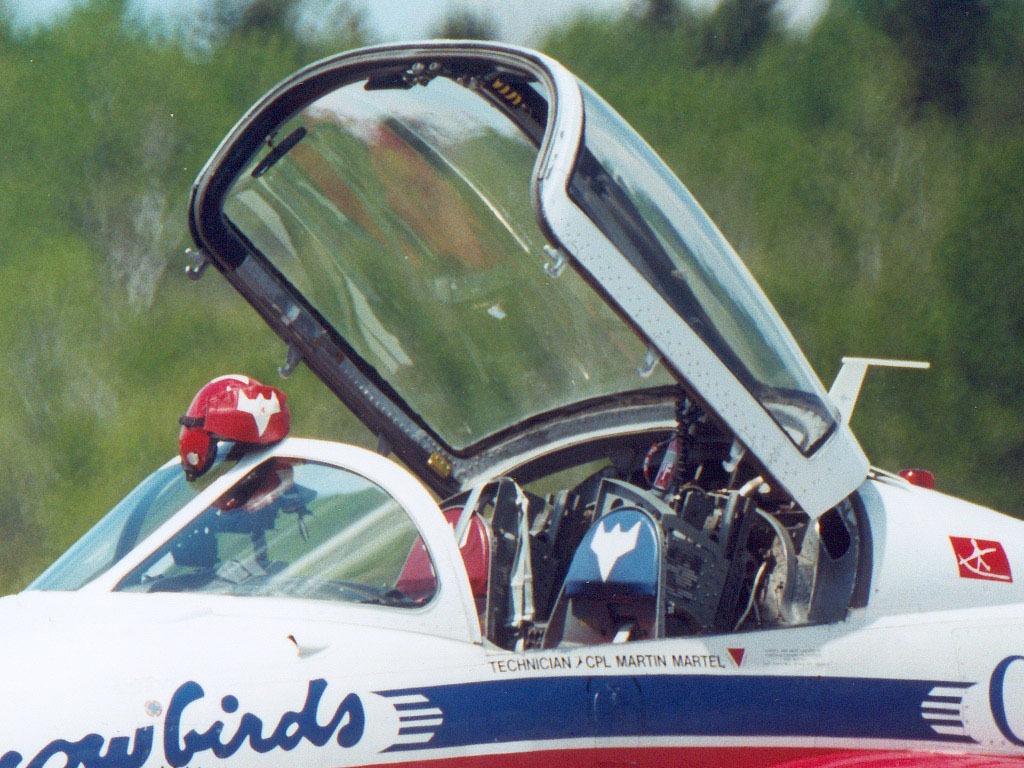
569;84;837;454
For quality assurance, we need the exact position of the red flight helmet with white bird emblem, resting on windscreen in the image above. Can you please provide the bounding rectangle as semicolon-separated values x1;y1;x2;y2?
178;374;291;480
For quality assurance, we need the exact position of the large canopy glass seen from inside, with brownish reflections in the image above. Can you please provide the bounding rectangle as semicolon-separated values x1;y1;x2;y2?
224;77;672;451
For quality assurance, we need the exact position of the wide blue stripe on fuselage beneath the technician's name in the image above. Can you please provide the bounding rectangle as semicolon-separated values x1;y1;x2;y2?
379;675;973;750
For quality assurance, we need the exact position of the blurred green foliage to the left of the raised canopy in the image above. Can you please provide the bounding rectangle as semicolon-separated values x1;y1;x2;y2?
0;0;368;591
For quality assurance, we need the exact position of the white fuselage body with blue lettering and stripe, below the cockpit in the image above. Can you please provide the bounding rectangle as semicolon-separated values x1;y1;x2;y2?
6;478;1024;768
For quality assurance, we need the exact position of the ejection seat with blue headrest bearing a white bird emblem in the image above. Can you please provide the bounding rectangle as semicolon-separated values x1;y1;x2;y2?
544;507;662;648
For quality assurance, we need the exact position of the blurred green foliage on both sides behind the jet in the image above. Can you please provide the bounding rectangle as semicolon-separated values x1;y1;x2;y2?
0;0;1024;591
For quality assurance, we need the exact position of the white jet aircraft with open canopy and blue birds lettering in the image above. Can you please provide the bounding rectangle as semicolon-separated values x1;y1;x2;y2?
8;41;1024;768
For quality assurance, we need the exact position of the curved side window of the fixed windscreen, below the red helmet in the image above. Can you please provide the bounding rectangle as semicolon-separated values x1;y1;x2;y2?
117;458;436;607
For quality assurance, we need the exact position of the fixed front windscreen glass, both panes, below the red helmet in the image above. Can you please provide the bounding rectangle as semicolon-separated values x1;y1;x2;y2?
29;451;437;608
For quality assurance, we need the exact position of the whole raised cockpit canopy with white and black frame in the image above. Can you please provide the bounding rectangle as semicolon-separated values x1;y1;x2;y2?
190;42;867;516
